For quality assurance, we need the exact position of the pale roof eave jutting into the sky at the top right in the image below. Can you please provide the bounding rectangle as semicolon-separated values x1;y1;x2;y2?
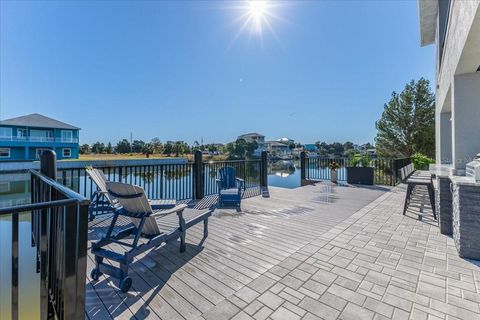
418;0;438;47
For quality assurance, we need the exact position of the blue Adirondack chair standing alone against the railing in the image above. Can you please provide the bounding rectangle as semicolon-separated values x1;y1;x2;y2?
217;167;245;207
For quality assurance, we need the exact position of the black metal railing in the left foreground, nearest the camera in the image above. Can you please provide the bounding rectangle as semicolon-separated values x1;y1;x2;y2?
0;170;89;320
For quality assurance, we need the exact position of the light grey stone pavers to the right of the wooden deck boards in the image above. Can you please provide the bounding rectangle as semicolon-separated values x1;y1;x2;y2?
87;186;480;320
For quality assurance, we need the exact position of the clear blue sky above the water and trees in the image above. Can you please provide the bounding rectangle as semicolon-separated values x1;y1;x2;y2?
0;0;434;143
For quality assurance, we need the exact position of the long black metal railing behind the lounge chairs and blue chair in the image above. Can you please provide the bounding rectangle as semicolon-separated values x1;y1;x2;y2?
57;153;267;209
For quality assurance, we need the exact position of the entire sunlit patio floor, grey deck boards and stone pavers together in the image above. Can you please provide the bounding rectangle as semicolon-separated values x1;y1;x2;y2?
86;183;480;320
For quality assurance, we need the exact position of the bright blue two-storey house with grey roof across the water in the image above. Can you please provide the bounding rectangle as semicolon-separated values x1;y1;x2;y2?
0;113;80;161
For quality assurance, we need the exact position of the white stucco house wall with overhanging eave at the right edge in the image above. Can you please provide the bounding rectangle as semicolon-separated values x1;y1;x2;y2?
419;0;480;170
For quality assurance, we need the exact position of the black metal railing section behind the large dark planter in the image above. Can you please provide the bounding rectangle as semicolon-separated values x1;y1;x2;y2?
305;157;411;186
